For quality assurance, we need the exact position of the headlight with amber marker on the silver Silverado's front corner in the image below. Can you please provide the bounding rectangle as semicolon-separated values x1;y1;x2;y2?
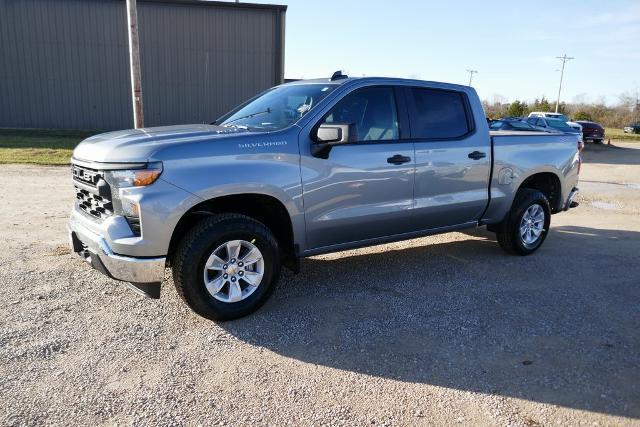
104;162;162;218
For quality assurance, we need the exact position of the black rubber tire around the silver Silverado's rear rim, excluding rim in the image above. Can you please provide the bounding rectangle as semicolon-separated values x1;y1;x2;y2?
496;188;551;255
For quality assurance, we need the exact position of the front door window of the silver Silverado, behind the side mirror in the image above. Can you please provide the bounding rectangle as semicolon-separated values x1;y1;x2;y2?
322;87;400;141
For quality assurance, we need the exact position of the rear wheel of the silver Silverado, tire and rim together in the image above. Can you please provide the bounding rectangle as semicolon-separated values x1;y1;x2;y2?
496;188;551;255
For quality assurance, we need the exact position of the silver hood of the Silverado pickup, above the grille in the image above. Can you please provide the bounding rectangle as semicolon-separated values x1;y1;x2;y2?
73;124;253;162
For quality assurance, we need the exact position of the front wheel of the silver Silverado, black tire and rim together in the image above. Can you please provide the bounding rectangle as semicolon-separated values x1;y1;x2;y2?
172;214;280;320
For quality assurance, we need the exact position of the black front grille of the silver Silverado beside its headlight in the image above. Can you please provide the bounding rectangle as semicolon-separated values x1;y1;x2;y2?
71;165;113;219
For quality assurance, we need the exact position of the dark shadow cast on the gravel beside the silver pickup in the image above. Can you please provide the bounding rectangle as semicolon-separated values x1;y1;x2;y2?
221;226;640;418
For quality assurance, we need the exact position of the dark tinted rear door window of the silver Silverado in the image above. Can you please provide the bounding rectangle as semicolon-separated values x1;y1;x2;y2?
408;88;472;139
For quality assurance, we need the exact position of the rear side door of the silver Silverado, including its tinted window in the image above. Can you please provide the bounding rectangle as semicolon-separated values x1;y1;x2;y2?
404;87;491;230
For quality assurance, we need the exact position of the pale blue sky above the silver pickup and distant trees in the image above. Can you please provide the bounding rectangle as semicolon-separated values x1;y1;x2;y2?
255;0;640;104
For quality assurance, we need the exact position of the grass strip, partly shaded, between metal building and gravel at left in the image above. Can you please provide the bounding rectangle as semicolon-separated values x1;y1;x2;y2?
0;129;96;165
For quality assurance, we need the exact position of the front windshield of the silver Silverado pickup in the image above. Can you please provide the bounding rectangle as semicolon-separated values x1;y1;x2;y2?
218;84;338;131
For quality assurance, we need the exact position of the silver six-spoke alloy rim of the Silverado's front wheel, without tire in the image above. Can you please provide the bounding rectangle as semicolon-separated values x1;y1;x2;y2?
204;240;264;303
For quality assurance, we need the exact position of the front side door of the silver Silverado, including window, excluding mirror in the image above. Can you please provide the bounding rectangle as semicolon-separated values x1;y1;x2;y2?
300;86;414;249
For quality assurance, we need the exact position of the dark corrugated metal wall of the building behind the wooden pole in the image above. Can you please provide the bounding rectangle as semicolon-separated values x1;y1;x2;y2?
0;0;286;130
